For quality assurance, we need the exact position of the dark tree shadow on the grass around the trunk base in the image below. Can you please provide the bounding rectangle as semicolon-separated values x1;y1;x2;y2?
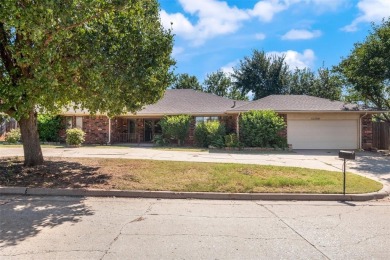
0;158;111;188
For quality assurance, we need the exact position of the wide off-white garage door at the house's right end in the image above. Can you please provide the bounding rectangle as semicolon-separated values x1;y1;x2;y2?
287;120;358;149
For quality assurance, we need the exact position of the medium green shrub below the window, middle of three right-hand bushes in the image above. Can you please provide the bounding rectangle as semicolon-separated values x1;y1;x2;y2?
195;121;226;148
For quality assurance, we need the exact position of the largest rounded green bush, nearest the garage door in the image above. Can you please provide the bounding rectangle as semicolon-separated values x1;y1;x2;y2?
240;110;286;147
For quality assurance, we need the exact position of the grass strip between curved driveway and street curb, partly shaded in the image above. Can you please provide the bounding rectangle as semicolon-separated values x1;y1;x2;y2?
0;157;382;194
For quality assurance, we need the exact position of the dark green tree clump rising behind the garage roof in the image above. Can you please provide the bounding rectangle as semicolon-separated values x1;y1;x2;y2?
232;50;343;100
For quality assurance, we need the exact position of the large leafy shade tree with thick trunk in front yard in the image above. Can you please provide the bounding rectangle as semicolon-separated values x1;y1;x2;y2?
0;0;174;166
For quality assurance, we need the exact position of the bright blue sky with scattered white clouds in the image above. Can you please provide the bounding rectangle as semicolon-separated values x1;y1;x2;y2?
159;0;390;82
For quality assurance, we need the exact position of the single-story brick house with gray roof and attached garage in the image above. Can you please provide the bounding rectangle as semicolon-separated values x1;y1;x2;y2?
60;89;379;149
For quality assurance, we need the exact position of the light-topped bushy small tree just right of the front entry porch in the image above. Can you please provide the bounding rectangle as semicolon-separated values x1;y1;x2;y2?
159;115;191;145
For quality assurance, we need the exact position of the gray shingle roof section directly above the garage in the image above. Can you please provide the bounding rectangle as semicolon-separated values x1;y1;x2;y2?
228;95;358;112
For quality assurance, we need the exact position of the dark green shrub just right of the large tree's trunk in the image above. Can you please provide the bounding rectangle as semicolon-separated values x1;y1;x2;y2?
38;115;62;142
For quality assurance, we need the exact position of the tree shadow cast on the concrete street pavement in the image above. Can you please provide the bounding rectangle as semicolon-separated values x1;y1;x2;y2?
0;196;94;247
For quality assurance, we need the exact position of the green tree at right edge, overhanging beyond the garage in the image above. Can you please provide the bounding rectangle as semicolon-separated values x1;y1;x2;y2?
336;18;390;122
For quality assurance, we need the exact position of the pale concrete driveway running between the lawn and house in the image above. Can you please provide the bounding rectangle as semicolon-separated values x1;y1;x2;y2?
0;146;390;184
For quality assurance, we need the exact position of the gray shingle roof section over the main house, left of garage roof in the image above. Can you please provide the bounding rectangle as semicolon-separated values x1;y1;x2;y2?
137;89;249;116
